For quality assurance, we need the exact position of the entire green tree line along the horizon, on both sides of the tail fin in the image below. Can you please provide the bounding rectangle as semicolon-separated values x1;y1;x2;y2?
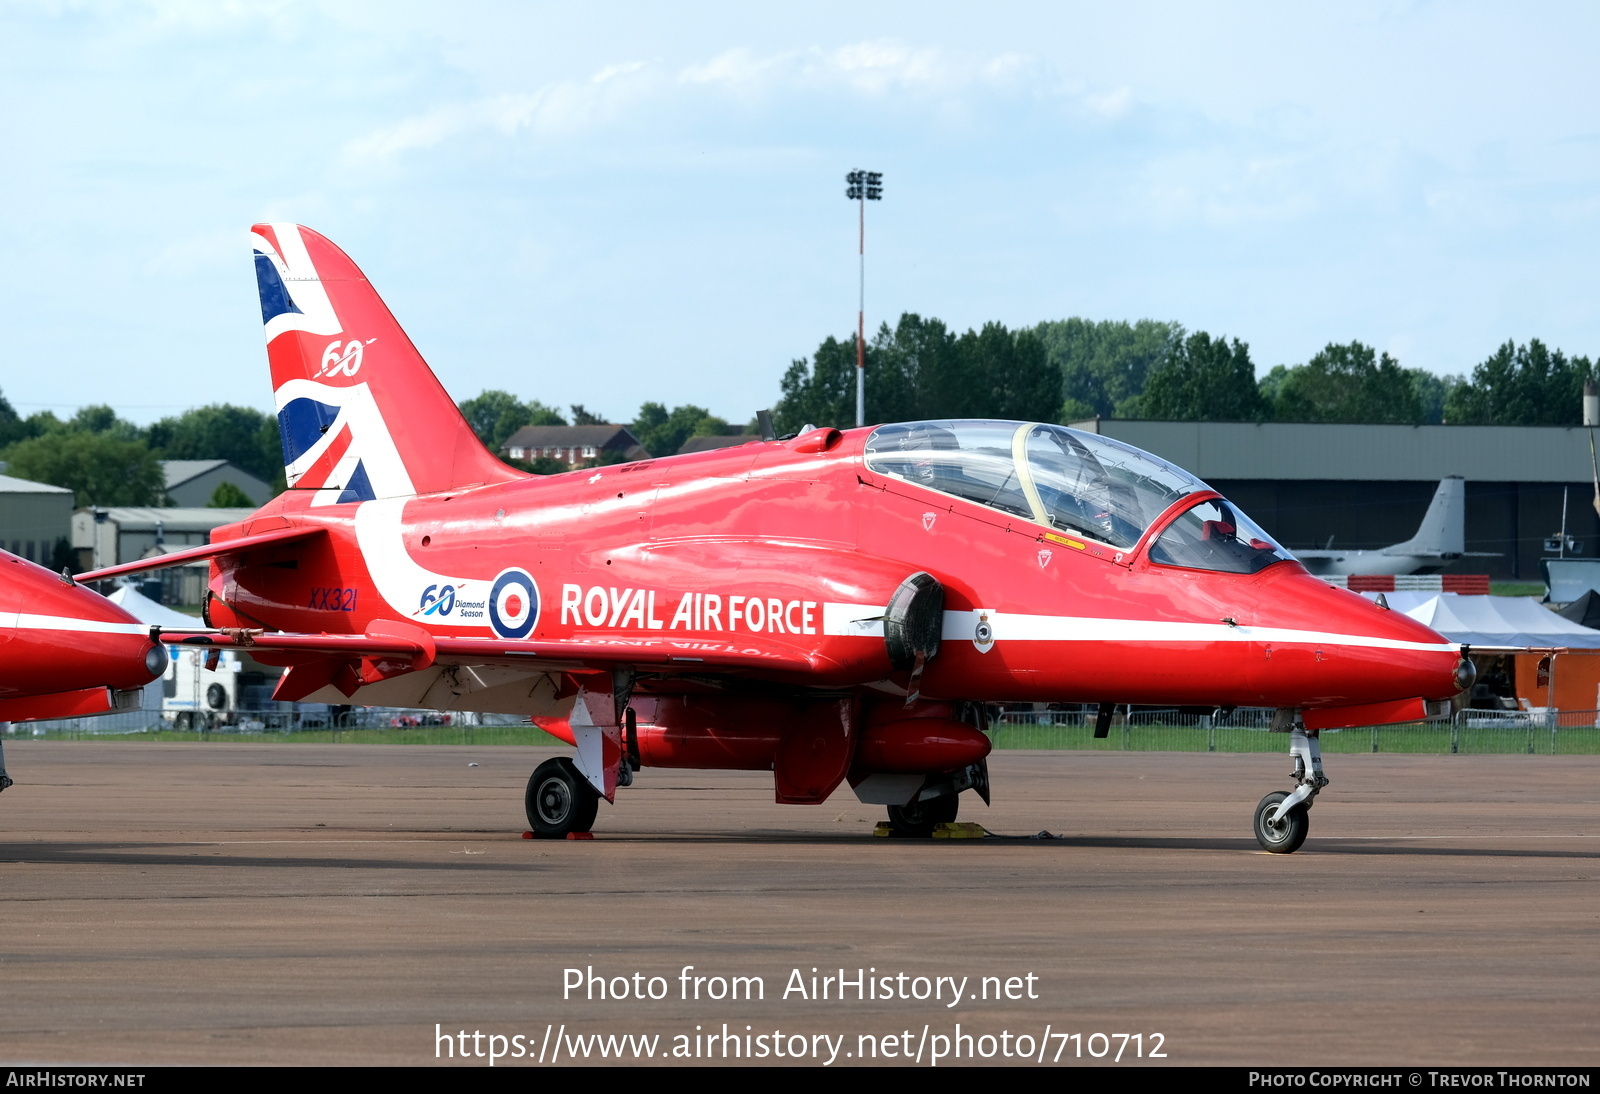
0;313;1597;507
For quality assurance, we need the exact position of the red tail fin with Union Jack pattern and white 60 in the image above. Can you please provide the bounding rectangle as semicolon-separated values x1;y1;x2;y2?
250;224;520;505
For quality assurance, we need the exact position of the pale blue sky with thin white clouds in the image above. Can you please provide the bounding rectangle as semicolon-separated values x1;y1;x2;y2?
0;0;1600;424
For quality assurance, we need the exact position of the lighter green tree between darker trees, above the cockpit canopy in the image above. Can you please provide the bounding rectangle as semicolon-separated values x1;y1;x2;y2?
1034;318;1184;422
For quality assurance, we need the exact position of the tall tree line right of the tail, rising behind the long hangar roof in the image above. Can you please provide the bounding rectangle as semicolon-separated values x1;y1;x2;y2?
773;313;1595;432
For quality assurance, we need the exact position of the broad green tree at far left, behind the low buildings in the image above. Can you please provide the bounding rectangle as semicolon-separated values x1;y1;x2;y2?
5;429;166;509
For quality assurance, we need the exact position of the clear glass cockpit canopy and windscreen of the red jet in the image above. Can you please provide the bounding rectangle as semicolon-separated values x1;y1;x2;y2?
866;421;1291;574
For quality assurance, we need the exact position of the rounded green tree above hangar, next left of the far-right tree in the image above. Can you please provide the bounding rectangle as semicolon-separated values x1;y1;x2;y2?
1261;342;1422;425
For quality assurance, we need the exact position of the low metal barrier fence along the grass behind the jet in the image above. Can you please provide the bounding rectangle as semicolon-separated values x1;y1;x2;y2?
11;707;1600;755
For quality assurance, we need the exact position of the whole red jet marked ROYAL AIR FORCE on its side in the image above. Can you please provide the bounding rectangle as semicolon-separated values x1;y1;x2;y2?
85;224;1470;852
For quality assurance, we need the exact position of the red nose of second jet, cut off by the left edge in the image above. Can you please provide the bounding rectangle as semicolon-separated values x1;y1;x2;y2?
0;550;166;790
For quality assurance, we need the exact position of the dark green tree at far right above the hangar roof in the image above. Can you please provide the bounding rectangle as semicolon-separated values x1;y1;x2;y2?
1445;339;1595;425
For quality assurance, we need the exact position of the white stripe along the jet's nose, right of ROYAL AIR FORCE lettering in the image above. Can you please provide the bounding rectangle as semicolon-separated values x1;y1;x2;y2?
822;603;1461;653
